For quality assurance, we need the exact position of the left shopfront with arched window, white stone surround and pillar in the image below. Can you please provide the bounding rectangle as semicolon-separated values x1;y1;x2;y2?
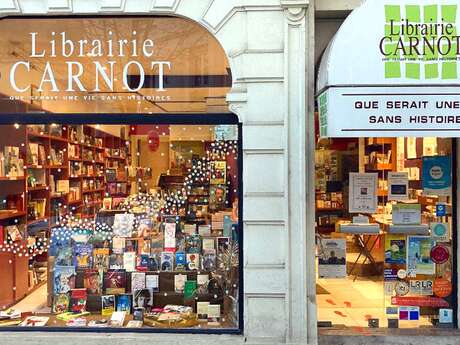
0;0;314;344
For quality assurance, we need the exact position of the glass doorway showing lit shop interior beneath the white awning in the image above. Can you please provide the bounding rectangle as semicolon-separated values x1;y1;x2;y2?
315;137;456;329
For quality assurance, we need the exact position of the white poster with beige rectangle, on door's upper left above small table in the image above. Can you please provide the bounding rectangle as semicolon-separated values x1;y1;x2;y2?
348;173;378;213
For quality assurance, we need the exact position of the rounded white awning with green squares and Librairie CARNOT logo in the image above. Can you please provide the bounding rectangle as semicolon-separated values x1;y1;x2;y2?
317;0;460;137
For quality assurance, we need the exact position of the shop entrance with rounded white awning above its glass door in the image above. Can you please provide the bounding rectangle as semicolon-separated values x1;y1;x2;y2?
315;0;460;334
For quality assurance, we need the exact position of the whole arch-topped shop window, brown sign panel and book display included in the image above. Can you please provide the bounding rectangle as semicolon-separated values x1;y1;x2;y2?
0;17;242;332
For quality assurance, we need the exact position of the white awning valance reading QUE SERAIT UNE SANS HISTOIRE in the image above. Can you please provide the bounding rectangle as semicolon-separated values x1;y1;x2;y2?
320;87;460;137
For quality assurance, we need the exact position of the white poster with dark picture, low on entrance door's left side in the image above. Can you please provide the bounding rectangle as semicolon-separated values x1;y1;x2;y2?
318;239;347;278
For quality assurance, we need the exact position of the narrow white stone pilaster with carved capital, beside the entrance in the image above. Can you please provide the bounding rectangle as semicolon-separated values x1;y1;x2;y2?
281;0;316;343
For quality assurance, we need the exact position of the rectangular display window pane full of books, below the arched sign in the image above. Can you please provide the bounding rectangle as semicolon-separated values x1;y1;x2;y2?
0;124;241;329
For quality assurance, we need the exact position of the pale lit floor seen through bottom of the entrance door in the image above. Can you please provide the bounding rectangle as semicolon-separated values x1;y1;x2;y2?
316;277;431;328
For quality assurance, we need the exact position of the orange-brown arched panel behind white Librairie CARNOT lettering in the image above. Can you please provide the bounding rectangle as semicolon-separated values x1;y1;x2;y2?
0;17;229;112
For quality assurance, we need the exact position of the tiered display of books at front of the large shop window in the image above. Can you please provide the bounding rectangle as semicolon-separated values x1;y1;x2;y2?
44;144;239;328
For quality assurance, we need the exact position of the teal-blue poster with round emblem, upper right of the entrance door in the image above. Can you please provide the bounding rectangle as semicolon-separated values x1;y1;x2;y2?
422;156;452;195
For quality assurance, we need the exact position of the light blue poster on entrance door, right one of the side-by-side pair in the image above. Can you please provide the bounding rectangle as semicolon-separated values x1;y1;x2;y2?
407;236;436;277
